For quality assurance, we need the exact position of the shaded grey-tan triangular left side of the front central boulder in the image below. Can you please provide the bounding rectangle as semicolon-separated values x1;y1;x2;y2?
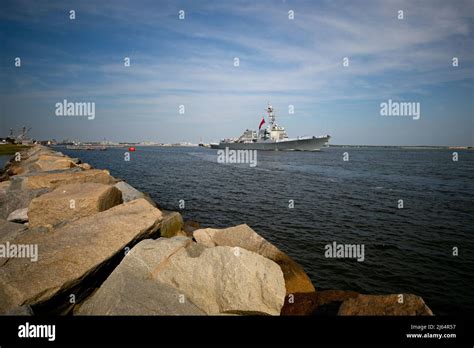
74;238;206;315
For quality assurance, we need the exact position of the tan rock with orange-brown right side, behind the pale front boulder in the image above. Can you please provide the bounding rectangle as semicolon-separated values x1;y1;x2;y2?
193;224;316;315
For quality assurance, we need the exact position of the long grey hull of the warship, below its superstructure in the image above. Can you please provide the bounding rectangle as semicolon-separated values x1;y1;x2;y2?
211;136;330;151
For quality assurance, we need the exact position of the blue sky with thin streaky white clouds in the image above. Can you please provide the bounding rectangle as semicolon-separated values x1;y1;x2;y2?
0;0;474;146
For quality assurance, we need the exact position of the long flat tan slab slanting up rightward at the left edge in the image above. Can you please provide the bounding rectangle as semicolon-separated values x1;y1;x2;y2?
0;199;162;313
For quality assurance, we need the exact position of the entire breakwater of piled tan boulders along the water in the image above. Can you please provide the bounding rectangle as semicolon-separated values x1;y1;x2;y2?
0;146;431;315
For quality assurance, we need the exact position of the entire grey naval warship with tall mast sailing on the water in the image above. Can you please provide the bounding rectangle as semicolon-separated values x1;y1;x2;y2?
210;104;331;151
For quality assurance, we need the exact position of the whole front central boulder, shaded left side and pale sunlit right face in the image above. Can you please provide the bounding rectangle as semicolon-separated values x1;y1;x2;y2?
78;237;285;315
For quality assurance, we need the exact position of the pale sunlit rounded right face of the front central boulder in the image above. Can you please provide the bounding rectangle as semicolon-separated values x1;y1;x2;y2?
154;237;285;315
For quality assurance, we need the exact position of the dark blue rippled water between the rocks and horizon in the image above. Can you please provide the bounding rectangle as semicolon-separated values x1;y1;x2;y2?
57;147;474;314
